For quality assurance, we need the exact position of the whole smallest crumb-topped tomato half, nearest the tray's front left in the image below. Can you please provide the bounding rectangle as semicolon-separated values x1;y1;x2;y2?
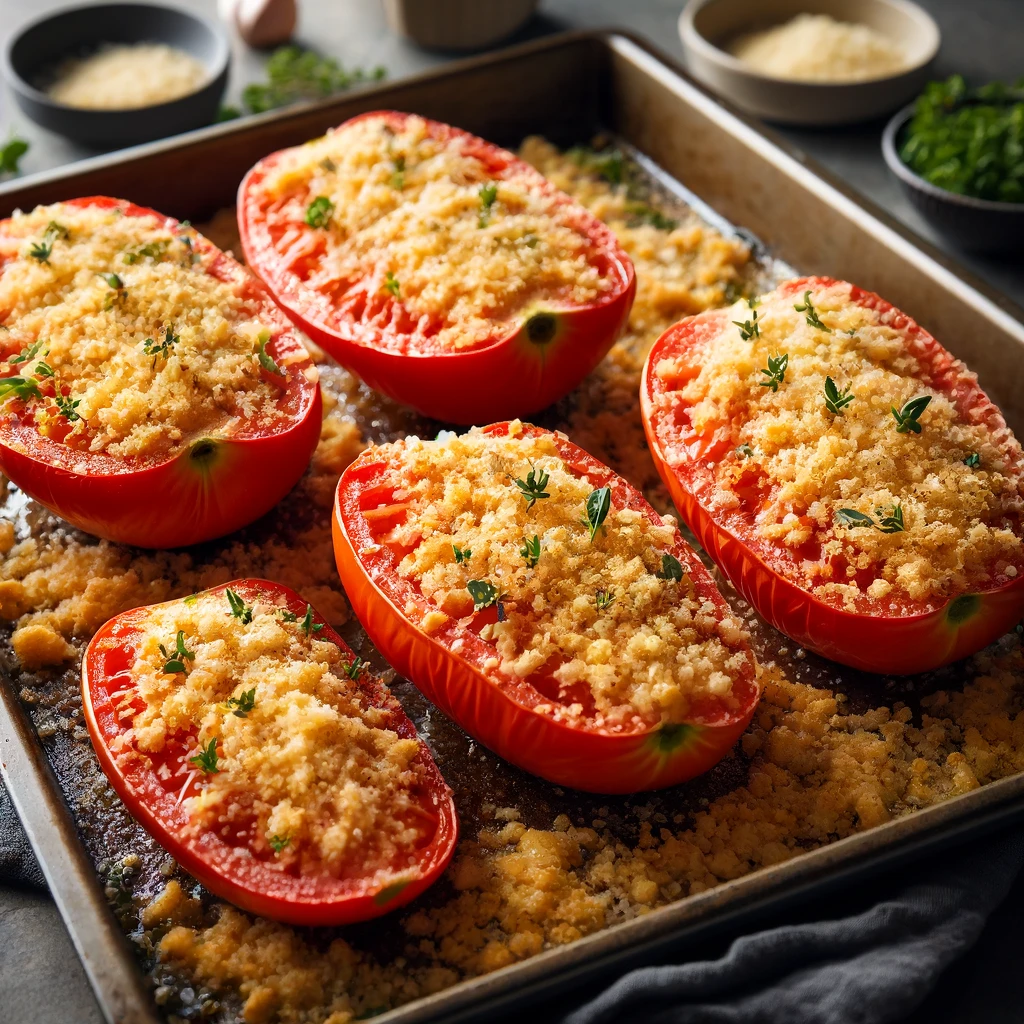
82;580;458;925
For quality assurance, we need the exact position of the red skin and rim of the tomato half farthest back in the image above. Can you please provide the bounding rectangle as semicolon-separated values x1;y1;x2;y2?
239;111;636;424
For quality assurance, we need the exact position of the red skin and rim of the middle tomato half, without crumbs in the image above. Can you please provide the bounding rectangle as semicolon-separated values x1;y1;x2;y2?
334;423;760;794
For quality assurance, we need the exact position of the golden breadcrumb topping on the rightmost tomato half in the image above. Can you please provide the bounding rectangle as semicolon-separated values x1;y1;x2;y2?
653;283;1024;610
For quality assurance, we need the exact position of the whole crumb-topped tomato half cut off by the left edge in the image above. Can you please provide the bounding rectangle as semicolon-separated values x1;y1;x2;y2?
0;197;322;548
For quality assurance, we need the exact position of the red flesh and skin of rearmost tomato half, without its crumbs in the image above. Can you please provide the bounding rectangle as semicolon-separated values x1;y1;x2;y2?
239;112;636;424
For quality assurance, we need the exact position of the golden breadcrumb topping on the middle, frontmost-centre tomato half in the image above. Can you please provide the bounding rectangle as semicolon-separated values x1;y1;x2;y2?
378;423;749;727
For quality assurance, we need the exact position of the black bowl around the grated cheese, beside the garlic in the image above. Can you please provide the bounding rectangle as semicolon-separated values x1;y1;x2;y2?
3;3;230;146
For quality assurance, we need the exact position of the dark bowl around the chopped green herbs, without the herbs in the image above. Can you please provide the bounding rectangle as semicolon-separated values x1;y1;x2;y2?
882;105;1024;253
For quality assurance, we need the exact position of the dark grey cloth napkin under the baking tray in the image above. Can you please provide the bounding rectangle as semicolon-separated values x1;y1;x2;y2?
0;785;1024;1024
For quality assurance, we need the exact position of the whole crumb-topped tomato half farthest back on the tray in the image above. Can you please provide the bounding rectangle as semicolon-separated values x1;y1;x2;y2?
239;112;636;423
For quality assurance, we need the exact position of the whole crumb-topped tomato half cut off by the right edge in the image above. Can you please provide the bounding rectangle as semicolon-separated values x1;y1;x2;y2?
641;278;1024;674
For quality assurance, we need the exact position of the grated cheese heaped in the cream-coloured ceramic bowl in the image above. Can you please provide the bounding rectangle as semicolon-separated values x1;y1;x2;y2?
728;14;906;82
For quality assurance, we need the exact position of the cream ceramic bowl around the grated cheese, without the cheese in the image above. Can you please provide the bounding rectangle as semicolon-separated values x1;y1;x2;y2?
679;0;940;126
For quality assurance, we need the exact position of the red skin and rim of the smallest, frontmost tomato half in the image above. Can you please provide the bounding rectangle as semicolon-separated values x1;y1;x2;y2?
82;580;459;926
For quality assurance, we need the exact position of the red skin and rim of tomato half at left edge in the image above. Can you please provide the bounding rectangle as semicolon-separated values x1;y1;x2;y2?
0;196;323;548
